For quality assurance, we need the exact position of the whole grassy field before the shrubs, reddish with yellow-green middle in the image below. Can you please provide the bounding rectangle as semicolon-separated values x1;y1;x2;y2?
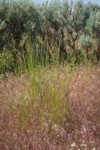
0;66;100;150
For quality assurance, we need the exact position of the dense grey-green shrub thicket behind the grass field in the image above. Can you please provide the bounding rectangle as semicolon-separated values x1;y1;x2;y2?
0;0;100;72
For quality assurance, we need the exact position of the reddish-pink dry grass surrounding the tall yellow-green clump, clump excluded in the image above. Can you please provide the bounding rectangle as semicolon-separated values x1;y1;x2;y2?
0;66;100;150
